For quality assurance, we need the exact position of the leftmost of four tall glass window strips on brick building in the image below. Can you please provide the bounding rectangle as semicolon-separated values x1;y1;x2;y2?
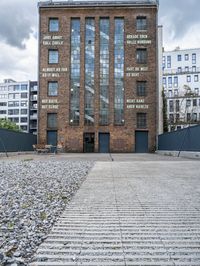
70;19;81;125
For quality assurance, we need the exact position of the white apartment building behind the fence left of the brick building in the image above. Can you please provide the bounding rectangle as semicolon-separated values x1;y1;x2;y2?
0;79;37;133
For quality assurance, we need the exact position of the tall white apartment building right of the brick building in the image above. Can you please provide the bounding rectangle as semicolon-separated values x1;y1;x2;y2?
163;48;200;131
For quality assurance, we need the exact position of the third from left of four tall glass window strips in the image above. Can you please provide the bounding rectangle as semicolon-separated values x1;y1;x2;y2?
99;18;110;125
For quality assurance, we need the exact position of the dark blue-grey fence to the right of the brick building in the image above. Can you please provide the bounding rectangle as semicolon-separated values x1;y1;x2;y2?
158;125;200;151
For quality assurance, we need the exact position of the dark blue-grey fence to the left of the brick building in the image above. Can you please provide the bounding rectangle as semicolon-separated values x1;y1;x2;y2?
0;128;37;152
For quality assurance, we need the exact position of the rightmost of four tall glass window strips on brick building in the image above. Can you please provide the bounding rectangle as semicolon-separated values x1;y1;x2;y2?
114;18;124;125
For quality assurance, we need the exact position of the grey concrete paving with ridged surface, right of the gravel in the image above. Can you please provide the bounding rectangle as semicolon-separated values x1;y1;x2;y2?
30;157;200;266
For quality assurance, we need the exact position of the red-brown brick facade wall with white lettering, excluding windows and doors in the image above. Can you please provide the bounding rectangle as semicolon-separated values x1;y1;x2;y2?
38;1;157;152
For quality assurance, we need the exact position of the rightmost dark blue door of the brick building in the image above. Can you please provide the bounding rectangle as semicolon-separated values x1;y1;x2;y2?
135;131;148;153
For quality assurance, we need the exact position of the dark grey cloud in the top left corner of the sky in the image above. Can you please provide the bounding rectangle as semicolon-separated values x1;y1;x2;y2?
0;0;37;49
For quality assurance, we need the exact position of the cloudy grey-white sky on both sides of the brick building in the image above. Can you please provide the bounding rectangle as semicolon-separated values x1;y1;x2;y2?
0;0;200;82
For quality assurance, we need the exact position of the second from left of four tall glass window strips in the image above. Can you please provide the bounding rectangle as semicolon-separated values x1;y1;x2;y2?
85;18;95;126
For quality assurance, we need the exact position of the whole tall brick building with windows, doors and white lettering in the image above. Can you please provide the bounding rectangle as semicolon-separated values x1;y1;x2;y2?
38;0;158;152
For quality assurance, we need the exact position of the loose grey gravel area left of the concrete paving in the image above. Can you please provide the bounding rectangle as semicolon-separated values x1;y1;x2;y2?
0;160;93;266
